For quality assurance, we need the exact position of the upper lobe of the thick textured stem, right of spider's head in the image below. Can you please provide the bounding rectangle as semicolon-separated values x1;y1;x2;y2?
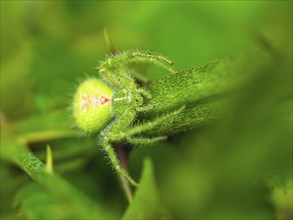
147;51;270;114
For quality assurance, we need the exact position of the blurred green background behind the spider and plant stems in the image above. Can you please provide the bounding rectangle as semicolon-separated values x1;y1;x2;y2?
1;1;292;219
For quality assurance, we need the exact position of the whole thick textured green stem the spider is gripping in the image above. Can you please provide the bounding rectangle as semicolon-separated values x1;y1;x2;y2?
142;51;272;135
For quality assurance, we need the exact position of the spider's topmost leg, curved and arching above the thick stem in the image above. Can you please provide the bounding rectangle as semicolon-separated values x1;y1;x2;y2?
100;50;176;73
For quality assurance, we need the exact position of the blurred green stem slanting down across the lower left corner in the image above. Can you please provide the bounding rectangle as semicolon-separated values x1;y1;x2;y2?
1;132;106;216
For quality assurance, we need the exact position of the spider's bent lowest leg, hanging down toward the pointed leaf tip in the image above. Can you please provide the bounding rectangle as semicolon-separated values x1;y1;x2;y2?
102;110;138;186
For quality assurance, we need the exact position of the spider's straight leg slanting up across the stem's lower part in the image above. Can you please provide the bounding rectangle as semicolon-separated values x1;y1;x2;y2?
111;106;185;141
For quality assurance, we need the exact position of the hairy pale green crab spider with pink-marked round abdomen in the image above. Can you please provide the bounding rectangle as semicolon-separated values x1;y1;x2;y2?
73;50;184;186
